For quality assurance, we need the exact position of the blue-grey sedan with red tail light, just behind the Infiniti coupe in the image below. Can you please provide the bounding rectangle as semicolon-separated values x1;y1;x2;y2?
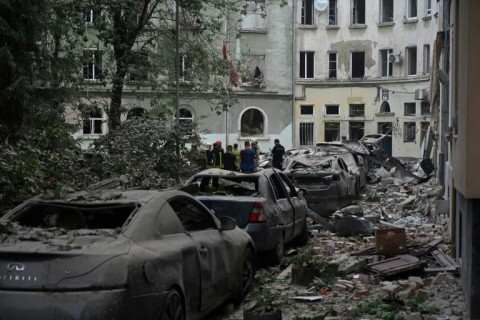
185;168;308;264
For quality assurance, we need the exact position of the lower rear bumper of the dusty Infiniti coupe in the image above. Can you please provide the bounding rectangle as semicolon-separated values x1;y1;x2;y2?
0;289;162;320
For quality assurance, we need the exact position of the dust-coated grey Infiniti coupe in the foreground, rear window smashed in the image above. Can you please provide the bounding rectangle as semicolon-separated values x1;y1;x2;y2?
0;190;255;320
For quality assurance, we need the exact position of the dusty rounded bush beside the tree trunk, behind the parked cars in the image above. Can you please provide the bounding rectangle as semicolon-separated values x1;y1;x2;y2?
90;118;200;189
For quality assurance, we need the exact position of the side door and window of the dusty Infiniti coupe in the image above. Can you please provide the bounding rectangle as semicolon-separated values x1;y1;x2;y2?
169;197;232;311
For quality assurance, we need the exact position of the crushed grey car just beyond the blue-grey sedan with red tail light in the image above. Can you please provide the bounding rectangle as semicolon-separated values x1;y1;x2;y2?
283;155;358;217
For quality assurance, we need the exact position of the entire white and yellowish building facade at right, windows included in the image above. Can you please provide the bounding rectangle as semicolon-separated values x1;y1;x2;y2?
294;0;438;157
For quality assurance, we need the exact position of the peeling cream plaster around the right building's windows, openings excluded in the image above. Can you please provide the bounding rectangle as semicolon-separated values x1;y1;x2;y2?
294;1;438;157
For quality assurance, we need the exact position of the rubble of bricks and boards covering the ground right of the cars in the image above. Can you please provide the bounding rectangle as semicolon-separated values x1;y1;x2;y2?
215;172;469;320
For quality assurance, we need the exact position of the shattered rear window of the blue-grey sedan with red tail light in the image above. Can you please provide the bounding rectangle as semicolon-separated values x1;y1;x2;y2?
192;176;258;196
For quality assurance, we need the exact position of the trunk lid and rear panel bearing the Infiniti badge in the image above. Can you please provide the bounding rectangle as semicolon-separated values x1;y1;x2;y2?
0;230;130;291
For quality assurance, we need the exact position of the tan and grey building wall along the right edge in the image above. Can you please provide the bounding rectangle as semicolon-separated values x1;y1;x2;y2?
431;0;480;319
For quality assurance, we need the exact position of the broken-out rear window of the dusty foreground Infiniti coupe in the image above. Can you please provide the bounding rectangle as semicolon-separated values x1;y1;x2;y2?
10;203;138;230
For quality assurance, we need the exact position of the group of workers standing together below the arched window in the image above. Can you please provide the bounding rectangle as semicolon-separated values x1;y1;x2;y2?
205;139;285;172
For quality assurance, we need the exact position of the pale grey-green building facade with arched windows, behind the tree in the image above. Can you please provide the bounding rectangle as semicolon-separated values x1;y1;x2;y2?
72;0;293;150
